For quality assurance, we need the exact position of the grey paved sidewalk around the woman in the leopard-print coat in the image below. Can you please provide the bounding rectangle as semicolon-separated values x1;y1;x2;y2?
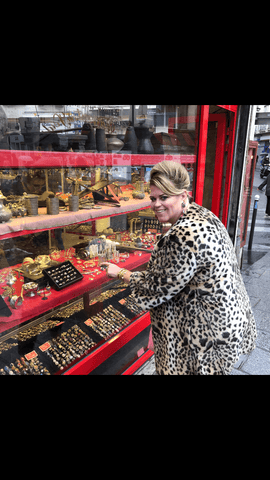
135;252;270;375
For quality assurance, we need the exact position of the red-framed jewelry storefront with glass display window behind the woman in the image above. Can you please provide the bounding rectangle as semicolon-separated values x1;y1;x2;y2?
0;105;247;375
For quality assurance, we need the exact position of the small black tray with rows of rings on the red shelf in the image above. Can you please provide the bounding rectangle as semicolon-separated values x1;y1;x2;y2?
42;260;83;291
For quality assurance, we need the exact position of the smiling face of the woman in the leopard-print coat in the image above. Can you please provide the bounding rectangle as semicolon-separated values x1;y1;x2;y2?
150;185;187;224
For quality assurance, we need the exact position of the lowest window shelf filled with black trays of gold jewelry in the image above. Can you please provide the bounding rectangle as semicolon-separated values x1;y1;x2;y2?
0;284;147;376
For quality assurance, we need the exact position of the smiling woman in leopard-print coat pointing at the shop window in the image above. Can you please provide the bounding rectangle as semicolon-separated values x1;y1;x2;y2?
102;161;256;375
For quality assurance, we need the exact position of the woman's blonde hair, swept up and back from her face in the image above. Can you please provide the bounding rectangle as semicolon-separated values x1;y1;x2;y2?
150;160;190;195
